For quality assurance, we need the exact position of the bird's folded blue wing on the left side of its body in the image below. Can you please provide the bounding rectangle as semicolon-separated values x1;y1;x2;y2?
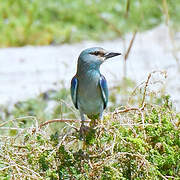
71;76;78;109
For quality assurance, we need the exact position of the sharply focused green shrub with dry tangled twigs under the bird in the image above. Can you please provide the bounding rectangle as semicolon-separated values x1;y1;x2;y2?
0;72;180;179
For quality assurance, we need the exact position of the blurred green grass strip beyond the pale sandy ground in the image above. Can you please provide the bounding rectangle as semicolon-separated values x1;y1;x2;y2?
0;0;180;47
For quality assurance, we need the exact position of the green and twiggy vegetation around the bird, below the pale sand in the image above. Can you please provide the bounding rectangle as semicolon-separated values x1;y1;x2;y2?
0;72;180;180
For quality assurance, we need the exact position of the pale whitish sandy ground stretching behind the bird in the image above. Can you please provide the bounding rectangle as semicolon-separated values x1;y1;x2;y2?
0;25;180;109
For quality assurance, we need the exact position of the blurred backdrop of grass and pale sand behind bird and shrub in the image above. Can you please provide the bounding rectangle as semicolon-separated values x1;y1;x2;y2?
0;0;180;119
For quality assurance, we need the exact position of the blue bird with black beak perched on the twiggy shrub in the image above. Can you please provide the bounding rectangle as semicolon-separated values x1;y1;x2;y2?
71;47;121;135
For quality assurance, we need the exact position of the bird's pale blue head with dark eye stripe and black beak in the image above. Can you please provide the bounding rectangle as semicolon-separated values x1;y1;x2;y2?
78;47;121;68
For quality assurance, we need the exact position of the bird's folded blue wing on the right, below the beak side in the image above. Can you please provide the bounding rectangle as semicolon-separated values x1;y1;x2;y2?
99;75;108;109
